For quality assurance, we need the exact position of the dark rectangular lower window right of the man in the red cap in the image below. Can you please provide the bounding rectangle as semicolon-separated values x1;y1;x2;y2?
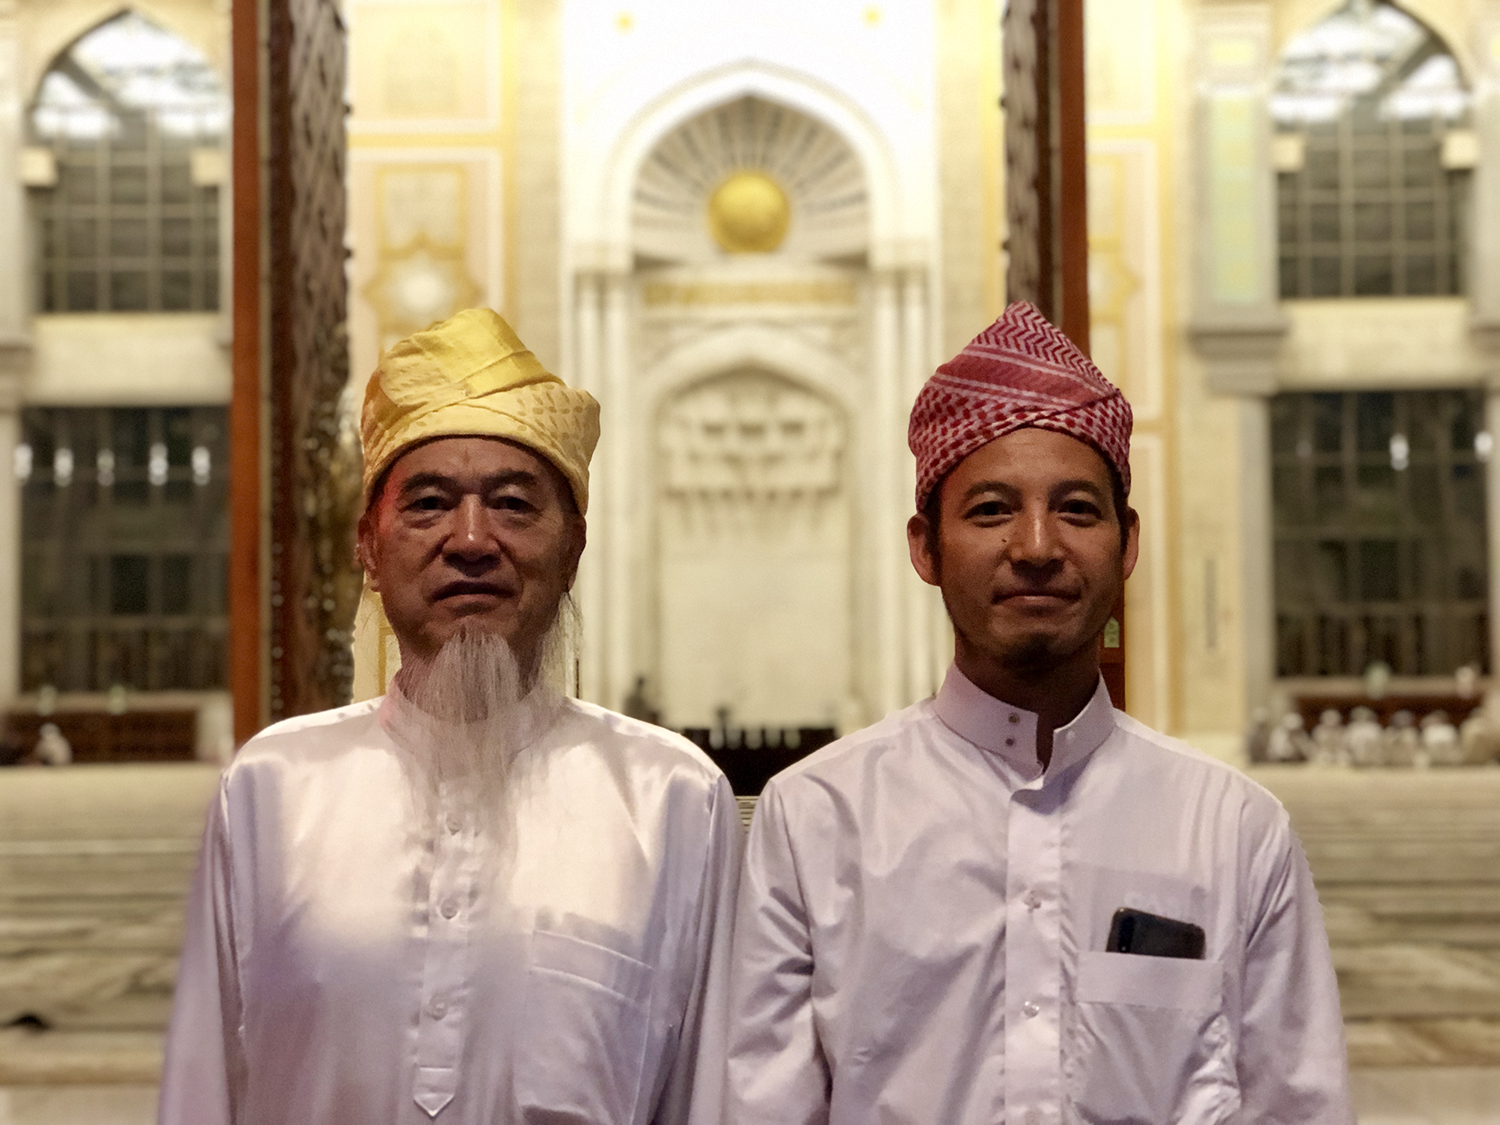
1272;390;1493;677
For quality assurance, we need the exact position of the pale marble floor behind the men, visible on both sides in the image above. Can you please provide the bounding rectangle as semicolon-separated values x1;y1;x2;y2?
0;765;1500;1125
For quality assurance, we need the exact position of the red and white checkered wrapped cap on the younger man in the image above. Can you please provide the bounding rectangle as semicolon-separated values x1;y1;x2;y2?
906;302;1131;512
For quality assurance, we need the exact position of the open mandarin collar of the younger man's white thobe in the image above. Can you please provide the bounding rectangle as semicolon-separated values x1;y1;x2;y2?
933;665;1115;780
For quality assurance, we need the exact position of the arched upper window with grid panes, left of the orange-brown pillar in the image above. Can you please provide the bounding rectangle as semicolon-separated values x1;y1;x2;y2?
26;12;230;312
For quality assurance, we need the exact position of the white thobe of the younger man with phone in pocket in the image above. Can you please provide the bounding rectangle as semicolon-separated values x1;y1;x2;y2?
726;669;1353;1125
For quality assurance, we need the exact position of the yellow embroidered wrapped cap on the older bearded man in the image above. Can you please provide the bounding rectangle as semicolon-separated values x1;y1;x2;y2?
360;309;599;515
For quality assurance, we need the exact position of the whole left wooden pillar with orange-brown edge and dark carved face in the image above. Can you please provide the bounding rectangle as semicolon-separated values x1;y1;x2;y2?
230;0;360;741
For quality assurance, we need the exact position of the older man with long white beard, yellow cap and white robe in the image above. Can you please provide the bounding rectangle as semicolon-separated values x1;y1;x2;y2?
161;309;740;1125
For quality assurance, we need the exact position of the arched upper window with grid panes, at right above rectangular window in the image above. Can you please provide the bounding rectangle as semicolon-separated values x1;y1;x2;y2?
1271;0;1472;297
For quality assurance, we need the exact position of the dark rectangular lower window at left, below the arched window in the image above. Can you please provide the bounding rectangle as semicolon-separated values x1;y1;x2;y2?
15;407;230;692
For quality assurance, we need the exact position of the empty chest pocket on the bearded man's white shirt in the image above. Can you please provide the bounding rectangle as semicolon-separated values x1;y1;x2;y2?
515;930;653;1125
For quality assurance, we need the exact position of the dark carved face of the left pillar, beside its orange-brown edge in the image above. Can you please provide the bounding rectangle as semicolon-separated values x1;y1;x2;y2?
267;0;360;720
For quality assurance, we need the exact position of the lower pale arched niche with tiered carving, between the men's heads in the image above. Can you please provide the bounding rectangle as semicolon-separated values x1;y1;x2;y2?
653;366;852;728
